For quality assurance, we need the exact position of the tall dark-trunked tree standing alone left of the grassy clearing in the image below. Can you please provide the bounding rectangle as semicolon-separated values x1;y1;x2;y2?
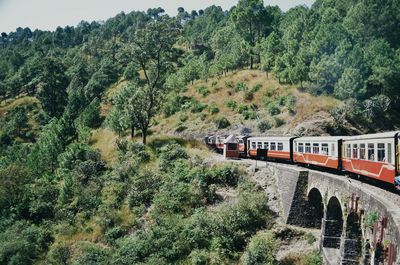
123;16;179;144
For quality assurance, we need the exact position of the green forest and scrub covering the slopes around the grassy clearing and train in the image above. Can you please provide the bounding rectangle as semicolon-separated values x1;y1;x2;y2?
0;0;400;264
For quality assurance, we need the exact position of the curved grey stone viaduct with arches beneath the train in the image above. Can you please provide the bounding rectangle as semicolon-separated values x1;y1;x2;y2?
266;162;400;265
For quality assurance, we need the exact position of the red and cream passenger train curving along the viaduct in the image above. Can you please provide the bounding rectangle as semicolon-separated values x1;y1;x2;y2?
205;132;400;190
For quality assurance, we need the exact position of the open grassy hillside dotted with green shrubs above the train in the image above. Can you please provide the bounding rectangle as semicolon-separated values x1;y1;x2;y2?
154;70;340;136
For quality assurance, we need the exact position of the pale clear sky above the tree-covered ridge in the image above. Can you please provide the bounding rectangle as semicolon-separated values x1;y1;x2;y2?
0;0;314;33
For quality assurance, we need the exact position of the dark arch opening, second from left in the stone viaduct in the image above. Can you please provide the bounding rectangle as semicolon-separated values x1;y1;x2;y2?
322;196;343;249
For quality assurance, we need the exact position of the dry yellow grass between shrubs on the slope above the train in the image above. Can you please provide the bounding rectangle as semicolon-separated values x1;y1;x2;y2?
154;70;340;137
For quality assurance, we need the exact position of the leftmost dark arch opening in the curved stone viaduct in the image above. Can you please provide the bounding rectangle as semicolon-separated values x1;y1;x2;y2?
307;188;324;228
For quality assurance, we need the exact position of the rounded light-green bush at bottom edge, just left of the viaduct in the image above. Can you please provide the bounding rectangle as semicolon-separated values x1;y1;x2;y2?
243;232;278;265
